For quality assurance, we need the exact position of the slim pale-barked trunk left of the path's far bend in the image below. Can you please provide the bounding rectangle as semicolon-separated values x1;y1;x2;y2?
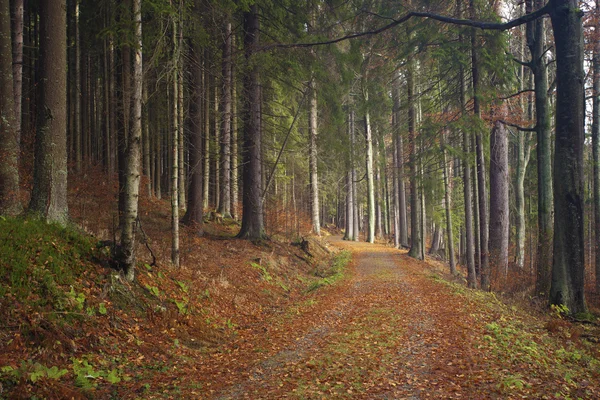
308;76;321;236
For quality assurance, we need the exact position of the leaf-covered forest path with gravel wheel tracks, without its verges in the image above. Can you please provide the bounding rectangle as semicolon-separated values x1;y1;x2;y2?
202;238;498;399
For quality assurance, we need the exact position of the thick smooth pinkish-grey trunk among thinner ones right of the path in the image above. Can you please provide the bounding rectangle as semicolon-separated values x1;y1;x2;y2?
490;121;510;274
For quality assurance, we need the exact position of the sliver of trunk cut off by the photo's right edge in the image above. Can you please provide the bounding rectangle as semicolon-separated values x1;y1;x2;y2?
590;0;600;294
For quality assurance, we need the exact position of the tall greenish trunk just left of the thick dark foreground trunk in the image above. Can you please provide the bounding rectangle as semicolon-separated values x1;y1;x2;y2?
526;0;561;296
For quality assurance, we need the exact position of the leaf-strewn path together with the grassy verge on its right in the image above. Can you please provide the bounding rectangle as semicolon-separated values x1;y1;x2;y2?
190;238;600;399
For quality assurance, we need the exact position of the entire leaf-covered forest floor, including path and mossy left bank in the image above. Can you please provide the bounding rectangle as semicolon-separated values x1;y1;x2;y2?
0;173;600;399
